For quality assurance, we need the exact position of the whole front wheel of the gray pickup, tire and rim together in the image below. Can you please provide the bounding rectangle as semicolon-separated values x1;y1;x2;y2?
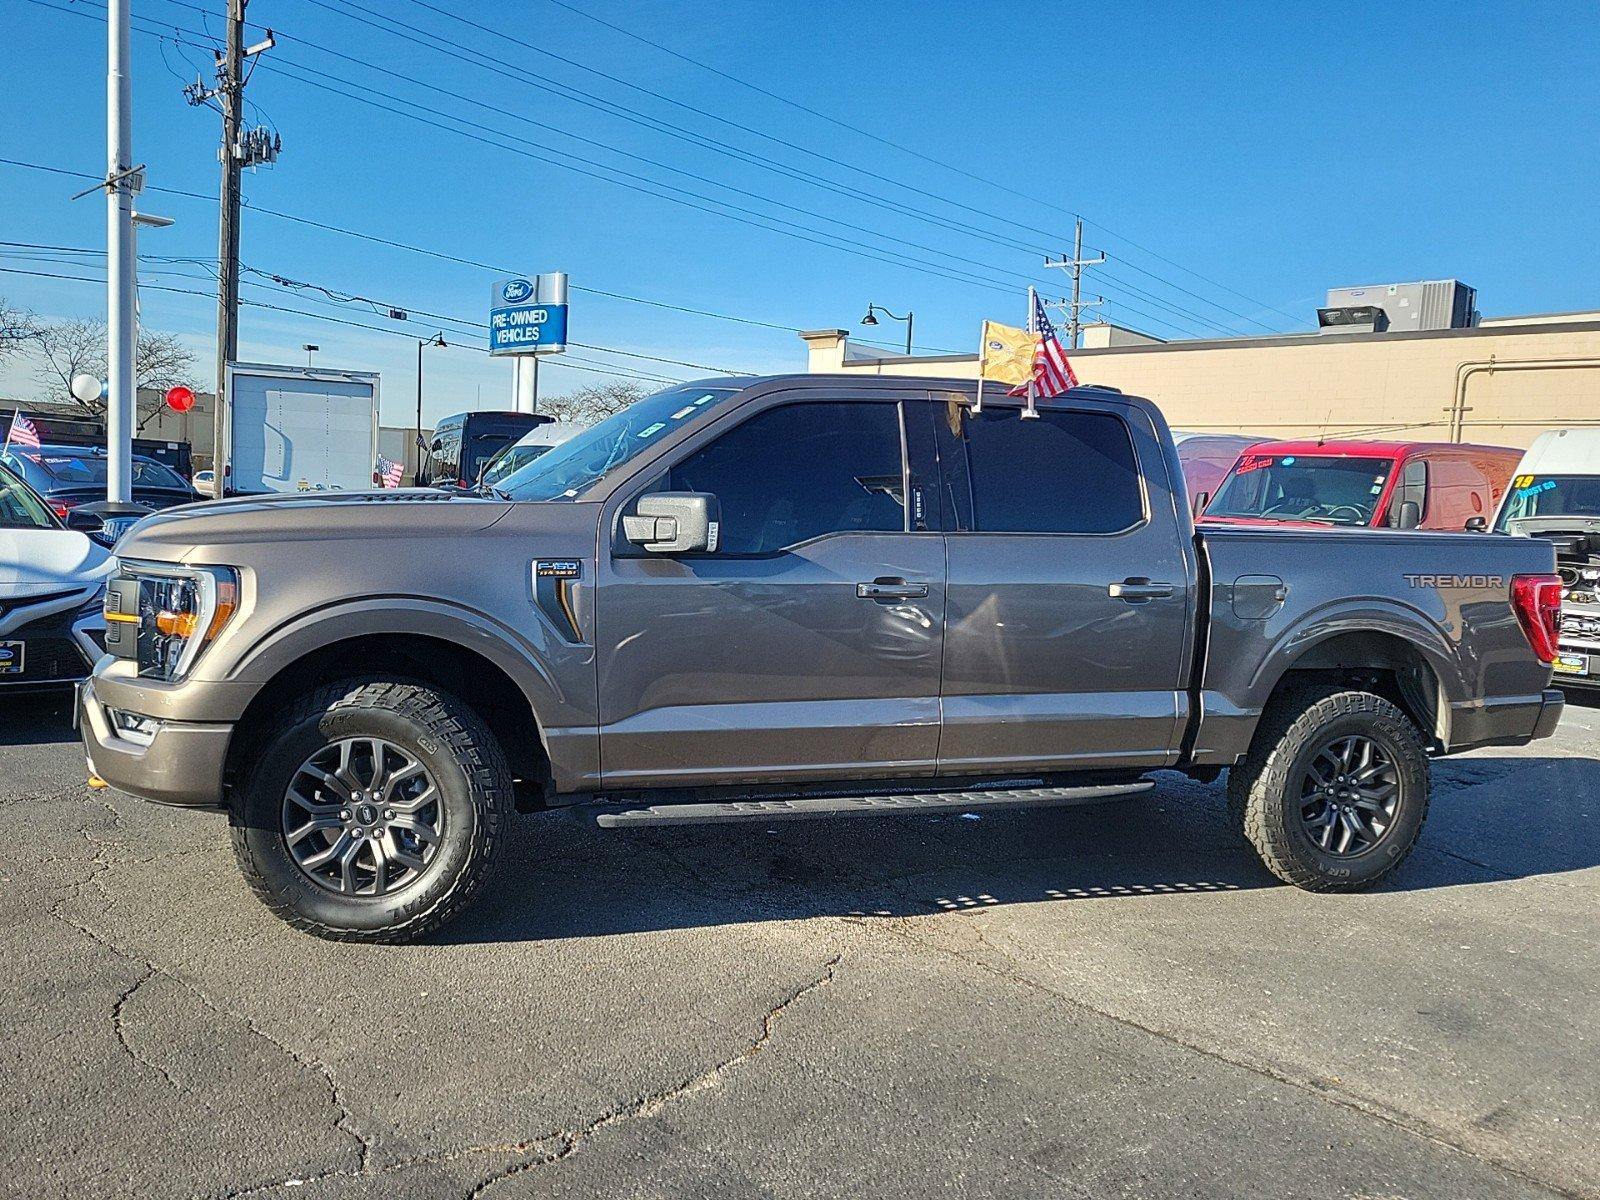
232;680;510;942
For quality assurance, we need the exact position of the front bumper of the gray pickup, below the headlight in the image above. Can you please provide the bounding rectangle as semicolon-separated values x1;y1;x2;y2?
77;678;234;808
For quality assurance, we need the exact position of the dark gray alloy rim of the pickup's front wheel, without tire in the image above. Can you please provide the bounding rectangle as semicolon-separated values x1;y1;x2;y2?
280;738;445;896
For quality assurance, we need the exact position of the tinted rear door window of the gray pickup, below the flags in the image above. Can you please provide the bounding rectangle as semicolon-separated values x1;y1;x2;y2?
952;406;1144;533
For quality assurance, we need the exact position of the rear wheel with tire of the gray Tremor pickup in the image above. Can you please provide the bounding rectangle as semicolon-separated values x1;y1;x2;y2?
1227;688;1429;891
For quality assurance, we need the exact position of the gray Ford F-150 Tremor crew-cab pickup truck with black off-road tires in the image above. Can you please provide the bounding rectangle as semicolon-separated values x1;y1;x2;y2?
78;374;1562;941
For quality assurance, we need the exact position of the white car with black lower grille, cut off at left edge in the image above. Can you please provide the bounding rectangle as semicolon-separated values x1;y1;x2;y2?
0;466;114;691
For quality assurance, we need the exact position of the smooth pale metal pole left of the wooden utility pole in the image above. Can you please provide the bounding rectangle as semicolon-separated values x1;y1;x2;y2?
106;0;139;504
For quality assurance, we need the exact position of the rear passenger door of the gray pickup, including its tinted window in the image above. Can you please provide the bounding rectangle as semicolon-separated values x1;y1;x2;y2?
934;403;1194;776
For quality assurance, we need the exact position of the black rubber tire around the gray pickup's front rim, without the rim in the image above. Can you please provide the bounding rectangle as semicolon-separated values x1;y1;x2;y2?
230;680;512;944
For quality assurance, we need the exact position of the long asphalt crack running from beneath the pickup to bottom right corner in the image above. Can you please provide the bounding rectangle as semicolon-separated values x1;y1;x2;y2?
840;910;1589;1200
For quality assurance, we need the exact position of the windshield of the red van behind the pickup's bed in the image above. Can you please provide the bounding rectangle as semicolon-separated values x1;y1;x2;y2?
1205;454;1394;525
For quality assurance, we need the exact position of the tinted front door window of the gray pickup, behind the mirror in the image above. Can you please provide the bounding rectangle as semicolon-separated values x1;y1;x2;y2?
661;402;906;554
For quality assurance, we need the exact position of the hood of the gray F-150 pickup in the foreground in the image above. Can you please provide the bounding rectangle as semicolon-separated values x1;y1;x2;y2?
117;488;512;562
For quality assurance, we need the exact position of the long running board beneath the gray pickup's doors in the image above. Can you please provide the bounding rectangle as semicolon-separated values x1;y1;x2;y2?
570;779;1155;829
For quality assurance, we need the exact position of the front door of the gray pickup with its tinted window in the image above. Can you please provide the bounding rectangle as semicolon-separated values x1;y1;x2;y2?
597;392;944;787
